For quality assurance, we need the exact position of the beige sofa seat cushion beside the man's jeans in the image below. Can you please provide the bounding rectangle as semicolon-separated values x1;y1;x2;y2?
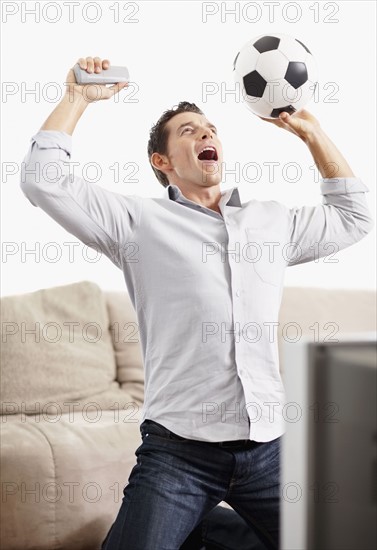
0;410;141;550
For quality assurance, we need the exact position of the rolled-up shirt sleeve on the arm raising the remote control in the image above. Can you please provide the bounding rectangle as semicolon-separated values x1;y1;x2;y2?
20;130;141;268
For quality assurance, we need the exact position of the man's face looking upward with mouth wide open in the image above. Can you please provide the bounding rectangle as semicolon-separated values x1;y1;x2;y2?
157;112;223;188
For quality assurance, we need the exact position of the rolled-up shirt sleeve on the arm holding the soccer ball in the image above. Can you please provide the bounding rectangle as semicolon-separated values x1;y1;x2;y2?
287;177;374;266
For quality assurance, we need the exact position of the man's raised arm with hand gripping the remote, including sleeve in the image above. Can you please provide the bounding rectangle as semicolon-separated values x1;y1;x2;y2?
20;57;141;268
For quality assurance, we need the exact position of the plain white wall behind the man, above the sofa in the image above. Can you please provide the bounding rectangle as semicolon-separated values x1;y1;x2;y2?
1;1;376;295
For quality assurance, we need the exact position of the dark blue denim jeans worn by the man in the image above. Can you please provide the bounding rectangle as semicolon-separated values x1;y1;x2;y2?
101;420;280;550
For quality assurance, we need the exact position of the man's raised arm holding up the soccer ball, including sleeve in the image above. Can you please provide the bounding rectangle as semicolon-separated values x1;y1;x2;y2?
263;110;374;266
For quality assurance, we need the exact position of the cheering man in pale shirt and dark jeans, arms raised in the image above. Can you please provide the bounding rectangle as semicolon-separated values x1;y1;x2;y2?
21;57;373;550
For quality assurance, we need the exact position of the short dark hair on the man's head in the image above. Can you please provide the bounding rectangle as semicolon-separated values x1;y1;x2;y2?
148;101;204;187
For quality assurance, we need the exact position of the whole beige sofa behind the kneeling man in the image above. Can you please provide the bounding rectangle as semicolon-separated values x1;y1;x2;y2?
0;281;376;550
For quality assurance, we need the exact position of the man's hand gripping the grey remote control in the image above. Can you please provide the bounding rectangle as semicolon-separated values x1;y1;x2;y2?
66;57;128;103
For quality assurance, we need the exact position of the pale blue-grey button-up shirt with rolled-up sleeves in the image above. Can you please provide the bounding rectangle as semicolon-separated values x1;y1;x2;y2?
21;130;374;441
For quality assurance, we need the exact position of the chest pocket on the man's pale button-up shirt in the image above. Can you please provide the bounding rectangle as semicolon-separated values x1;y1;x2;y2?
243;227;285;286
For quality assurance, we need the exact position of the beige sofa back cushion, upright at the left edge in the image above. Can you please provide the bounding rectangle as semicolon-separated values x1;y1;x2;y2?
1;281;122;414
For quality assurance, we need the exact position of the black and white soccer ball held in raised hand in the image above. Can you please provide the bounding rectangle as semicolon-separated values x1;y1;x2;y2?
233;33;317;118
